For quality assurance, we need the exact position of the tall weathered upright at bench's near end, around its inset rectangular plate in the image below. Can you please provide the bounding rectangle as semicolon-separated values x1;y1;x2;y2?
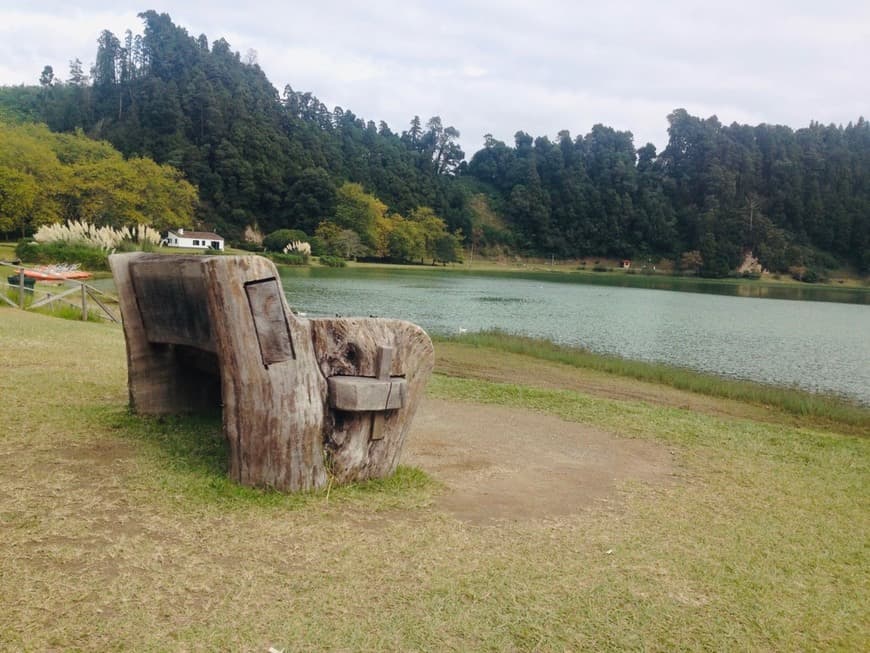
203;256;327;490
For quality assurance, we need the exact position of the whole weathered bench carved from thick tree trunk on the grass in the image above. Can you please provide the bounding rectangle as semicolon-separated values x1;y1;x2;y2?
109;253;434;491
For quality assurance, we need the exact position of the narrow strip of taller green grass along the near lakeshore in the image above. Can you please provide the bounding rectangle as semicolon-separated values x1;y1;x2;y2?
444;331;870;429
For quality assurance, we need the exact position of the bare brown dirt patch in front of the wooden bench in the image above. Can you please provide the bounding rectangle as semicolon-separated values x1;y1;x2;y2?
404;399;673;523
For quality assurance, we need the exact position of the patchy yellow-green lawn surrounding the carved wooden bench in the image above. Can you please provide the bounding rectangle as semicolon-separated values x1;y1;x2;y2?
0;309;870;652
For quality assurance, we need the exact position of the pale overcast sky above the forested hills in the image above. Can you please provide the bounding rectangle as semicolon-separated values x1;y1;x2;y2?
0;0;870;155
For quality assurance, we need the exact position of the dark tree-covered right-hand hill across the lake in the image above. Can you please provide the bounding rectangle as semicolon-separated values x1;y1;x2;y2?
468;109;870;276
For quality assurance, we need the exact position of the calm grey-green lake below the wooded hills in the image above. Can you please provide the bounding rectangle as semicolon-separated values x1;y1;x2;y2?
281;267;870;405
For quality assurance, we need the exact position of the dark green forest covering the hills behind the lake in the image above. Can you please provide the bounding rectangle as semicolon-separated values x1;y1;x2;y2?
0;11;870;277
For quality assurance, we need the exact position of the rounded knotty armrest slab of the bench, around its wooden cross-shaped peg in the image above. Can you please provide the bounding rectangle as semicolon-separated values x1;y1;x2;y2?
310;318;435;483
